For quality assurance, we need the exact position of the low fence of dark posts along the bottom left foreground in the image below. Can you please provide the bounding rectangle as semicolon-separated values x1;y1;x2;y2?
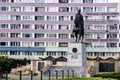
0;70;74;80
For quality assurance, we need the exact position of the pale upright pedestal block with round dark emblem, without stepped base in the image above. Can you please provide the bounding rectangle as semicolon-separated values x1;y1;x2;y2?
67;43;86;67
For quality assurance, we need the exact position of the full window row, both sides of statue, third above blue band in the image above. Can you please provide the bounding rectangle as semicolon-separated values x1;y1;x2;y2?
0;24;120;31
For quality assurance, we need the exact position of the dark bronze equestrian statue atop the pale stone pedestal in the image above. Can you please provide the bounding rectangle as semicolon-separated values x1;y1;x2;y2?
71;9;84;42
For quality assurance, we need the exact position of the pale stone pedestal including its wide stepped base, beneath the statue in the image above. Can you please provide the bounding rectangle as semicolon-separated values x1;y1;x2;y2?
46;43;86;77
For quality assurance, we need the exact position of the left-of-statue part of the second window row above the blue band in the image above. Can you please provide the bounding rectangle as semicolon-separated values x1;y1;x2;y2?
0;33;69;39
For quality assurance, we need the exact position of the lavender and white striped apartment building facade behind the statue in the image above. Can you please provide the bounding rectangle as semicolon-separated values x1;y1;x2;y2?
0;0;120;59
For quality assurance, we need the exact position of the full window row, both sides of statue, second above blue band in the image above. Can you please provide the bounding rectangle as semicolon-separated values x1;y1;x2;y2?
0;33;117;39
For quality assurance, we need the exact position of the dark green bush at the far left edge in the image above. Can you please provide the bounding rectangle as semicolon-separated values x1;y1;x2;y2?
0;56;12;77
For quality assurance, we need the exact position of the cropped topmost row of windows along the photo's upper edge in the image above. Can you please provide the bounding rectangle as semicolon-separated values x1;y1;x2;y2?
0;0;107;3
